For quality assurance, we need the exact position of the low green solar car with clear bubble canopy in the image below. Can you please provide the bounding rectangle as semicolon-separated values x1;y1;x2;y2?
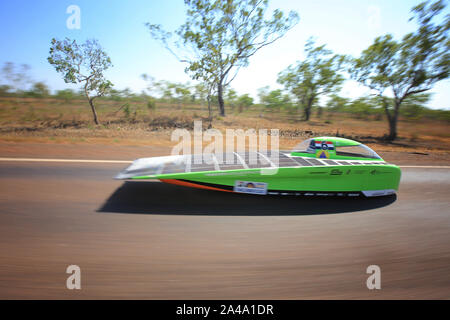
116;137;401;197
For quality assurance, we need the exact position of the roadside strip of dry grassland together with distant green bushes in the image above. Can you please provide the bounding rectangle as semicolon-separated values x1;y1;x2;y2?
0;63;450;153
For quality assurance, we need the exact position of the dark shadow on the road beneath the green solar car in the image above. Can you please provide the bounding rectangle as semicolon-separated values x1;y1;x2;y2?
97;182;397;216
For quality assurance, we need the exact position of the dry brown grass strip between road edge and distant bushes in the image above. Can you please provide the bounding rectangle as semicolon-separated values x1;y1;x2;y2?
0;98;450;153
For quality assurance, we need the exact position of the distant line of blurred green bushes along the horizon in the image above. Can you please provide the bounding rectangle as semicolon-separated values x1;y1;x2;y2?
0;74;450;122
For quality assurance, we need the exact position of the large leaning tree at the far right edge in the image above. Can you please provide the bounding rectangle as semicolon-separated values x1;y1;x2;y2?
351;0;450;140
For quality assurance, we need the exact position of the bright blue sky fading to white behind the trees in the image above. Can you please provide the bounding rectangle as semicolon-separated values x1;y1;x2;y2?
0;0;450;109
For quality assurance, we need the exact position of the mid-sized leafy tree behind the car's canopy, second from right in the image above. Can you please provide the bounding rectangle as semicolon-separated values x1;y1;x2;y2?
278;39;346;120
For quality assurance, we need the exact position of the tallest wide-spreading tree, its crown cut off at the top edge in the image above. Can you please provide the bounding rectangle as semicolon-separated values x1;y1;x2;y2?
146;0;299;116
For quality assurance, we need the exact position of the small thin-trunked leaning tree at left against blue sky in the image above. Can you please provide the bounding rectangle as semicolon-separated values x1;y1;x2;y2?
47;38;113;124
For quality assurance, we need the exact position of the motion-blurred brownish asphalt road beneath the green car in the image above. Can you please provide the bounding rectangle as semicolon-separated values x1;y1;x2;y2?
0;162;450;299
